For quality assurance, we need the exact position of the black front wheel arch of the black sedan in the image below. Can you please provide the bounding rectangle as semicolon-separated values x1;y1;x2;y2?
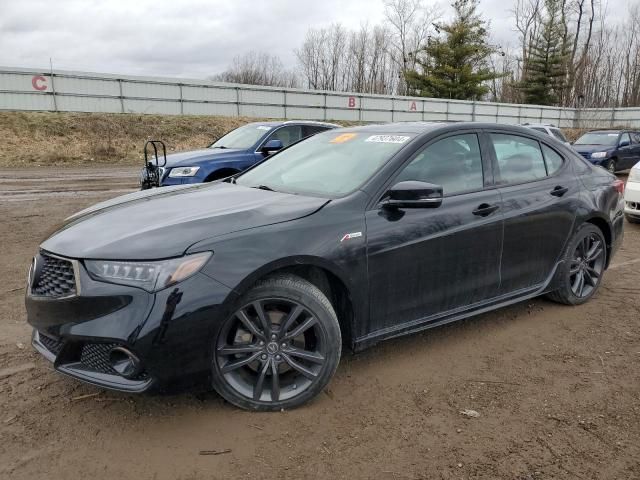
234;256;360;349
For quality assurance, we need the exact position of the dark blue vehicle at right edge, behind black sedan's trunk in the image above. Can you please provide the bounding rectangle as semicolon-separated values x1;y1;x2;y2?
573;130;640;173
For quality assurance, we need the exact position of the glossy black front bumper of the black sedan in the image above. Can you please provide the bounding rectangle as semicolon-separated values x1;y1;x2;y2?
25;253;235;392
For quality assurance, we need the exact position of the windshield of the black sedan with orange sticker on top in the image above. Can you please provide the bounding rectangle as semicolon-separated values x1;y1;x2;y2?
236;130;412;197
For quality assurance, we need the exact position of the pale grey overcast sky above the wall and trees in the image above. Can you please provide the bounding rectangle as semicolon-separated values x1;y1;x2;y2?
0;0;629;78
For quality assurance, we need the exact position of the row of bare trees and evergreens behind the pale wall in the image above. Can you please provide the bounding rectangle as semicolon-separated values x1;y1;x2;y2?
212;0;640;107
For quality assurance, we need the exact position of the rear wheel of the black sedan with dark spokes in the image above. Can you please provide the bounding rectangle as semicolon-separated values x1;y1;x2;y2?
548;223;607;305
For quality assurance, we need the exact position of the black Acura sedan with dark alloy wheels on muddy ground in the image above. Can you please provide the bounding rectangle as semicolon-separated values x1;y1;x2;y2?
26;123;624;410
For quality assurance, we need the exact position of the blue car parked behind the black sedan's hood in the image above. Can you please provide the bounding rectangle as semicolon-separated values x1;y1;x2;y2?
141;121;339;188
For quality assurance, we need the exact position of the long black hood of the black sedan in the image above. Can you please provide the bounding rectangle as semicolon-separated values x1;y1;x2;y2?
41;182;328;260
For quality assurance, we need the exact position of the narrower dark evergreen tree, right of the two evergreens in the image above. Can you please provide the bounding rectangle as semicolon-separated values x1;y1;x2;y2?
519;0;568;105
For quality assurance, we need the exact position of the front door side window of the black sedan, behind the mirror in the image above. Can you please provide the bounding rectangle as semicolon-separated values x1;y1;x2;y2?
396;134;484;195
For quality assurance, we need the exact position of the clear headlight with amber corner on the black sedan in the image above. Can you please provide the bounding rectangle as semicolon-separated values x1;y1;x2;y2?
84;252;212;293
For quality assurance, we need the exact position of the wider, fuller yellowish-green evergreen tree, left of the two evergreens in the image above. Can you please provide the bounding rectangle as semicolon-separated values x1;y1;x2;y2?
406;0;502;100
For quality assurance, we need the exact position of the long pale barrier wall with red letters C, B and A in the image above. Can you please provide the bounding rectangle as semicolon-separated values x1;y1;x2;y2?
0;67;640;128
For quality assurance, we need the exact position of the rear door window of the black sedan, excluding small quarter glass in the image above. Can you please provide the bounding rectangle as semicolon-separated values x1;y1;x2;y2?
490;133;547;183
